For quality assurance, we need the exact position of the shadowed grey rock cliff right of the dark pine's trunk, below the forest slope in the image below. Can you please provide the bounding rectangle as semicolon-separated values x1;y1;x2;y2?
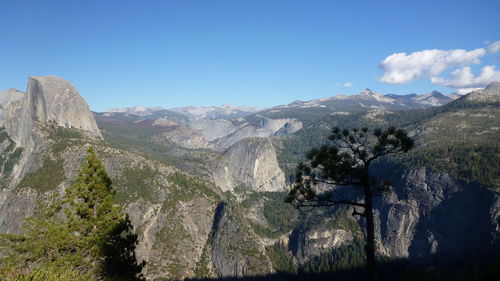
375;168;500;258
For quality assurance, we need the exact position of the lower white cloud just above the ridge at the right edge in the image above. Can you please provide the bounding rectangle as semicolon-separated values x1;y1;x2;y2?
431;65;500;90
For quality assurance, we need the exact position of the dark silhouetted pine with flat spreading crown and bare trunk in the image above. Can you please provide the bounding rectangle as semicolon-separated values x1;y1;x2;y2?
286;127;413;281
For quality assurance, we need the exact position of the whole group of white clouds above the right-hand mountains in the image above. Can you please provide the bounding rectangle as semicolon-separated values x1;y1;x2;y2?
379;41;500;94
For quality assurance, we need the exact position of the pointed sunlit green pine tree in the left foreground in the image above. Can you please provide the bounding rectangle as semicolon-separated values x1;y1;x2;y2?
65;148;144;280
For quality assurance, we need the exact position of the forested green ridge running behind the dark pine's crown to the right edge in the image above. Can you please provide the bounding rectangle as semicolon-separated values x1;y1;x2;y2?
274;99;500;188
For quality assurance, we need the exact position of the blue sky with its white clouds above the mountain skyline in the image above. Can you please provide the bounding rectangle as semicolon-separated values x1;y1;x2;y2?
0;0;500;111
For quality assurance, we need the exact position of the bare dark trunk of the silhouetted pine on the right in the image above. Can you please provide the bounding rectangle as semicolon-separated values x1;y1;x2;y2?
364;186;378;281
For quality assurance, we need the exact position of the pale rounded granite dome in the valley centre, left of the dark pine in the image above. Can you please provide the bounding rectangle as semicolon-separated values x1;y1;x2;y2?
212;138;285;194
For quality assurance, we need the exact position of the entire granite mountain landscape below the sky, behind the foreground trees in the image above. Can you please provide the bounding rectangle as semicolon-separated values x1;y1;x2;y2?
0;76;500;280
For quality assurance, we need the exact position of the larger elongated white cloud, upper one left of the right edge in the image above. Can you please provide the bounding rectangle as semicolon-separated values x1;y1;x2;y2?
380;47;486;84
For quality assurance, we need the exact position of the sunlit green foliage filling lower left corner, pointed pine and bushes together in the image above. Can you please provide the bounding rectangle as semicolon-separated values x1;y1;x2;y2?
0;149;143;281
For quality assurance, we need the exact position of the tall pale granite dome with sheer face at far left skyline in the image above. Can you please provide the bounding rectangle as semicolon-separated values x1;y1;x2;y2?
0;76;102;186
